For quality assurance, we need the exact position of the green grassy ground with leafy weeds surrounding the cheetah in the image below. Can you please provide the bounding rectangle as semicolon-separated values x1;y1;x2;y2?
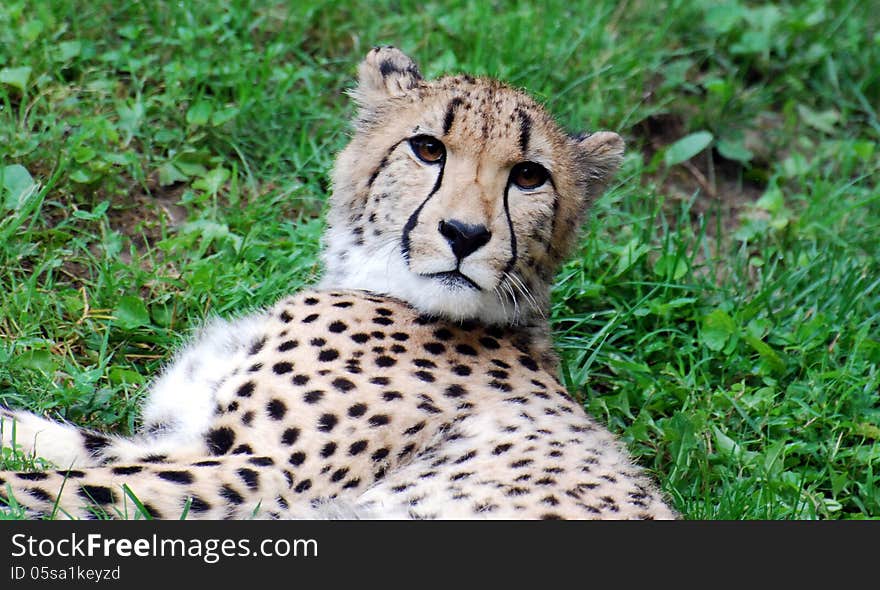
0;0;880;519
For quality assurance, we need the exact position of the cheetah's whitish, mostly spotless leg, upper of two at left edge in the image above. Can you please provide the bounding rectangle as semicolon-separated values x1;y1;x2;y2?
0;408;207;468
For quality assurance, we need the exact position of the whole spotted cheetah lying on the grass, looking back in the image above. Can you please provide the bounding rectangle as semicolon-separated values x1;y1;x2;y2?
0;47;676;519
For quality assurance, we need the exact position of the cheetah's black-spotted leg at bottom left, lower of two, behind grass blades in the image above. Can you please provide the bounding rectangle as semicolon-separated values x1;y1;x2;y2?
0;455;293;520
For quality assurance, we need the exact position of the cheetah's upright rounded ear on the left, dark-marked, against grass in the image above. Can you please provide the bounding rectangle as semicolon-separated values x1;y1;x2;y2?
354;45;423;106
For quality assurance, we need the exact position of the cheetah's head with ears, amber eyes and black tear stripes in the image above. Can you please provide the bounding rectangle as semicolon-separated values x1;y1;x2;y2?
324;47;623;324
